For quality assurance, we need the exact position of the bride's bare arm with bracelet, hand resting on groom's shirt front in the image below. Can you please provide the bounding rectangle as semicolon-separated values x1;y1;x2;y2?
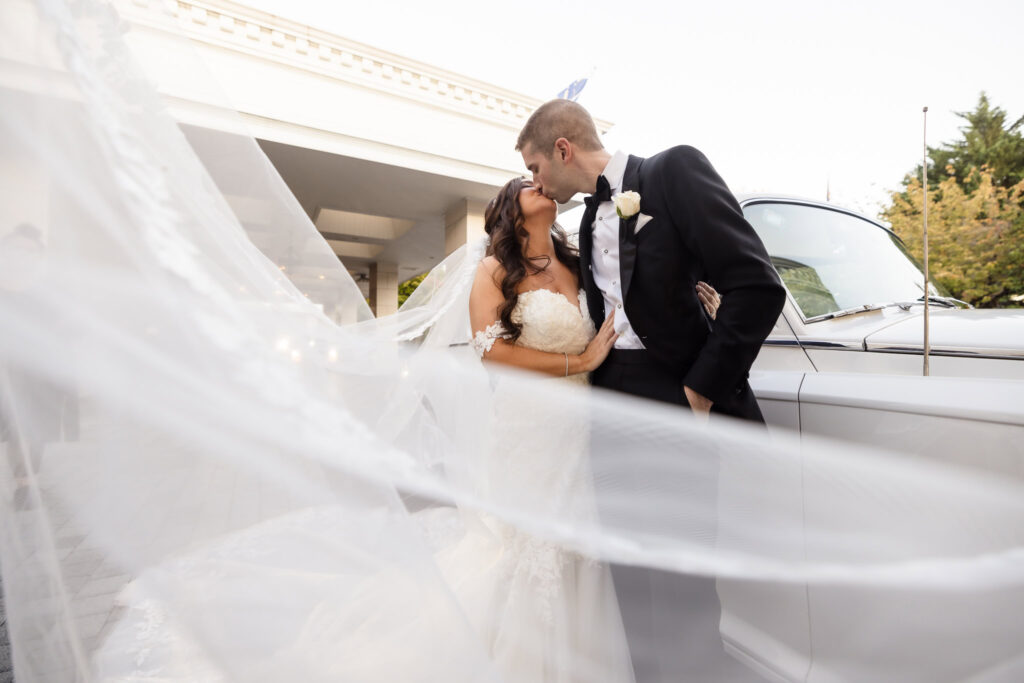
469;258;618;377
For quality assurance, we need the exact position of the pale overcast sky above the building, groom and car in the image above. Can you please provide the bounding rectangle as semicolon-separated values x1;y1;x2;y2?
242;0;1024;214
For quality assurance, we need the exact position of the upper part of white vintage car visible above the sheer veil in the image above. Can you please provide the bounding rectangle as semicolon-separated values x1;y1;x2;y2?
740;196;1024;456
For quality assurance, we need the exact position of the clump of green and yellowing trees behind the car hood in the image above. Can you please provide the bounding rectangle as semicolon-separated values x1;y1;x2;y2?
882;92;1024;307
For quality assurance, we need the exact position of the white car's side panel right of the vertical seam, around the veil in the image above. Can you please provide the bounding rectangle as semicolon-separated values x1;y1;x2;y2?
800;373;1024;682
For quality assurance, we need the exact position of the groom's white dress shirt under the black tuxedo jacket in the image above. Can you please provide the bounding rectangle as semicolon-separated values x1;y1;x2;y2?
591;152;644;348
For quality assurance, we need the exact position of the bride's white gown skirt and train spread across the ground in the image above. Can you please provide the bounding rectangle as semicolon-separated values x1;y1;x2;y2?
95;508;633;683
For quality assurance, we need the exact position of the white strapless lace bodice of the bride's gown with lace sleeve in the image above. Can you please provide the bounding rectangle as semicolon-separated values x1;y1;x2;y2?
472;289;597;385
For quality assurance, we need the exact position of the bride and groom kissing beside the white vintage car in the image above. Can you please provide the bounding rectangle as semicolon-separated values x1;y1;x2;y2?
460;99;785;681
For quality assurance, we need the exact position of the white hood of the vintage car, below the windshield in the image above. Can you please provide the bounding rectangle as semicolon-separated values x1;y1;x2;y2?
864;308;1024;359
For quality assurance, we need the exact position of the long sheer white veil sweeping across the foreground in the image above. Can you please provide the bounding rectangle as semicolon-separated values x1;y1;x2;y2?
0;0;1024;681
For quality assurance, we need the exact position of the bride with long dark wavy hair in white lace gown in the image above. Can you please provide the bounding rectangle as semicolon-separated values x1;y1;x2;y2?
462;178;633;681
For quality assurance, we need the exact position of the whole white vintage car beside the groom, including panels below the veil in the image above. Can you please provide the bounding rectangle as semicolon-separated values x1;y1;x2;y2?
718;196;1024;681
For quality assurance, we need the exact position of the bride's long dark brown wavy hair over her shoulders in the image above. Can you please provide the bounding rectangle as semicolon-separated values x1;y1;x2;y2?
483;178;580;342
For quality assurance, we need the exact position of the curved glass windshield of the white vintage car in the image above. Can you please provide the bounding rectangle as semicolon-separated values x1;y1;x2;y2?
743;203;946;318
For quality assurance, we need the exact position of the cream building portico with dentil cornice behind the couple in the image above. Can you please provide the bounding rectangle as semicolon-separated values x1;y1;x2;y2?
118;0;610;315
